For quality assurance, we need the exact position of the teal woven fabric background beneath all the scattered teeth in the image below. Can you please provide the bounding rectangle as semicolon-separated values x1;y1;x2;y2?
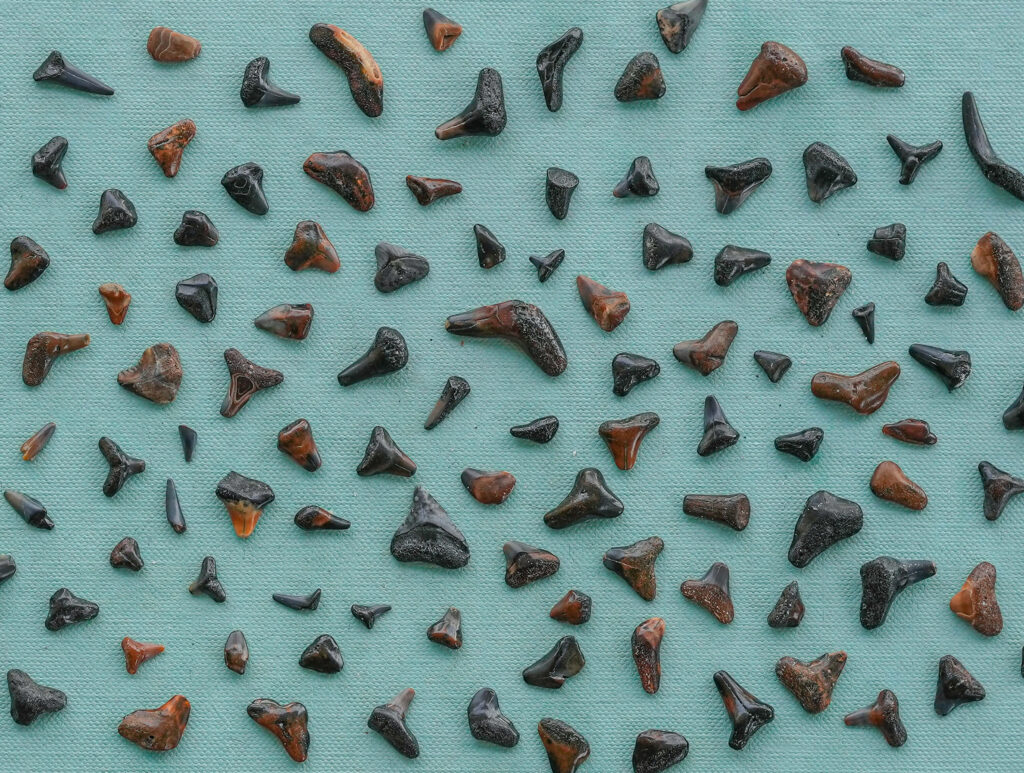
0;0;1024;773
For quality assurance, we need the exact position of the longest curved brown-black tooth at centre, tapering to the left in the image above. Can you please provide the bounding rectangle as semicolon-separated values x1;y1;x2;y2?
444;300;568;376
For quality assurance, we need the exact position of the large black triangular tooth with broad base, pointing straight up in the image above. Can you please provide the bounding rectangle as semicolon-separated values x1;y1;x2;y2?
391;486;469;569
